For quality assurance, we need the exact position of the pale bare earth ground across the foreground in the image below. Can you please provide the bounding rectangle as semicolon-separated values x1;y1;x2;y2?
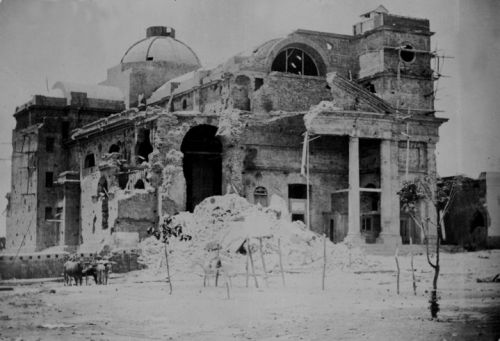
0;250;500;340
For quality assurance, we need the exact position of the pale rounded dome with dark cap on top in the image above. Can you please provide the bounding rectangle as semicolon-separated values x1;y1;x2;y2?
121;26;201;68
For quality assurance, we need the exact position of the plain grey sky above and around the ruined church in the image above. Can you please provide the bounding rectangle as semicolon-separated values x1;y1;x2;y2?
0;0;500;235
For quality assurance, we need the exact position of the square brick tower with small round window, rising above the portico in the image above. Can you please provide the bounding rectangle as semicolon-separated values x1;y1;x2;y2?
353;6;434;114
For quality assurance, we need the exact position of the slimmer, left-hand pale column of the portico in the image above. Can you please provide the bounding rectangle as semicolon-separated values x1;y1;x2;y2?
346;136;364;243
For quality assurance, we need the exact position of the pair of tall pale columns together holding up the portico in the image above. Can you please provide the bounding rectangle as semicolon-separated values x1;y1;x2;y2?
346;136;401;244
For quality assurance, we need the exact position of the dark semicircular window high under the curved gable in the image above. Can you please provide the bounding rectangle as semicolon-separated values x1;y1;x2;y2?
271;47;319;76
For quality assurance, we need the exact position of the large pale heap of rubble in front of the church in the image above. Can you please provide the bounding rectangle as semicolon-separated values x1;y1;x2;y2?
139;194;366;273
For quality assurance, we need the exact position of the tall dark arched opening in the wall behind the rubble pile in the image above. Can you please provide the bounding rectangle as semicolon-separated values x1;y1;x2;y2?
181;125;222;211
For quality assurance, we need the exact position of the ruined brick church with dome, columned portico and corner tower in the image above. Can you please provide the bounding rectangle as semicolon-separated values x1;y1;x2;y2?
6;6;446;252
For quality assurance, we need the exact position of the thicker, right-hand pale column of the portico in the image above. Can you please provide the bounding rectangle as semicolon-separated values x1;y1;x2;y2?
377;139;401;245
